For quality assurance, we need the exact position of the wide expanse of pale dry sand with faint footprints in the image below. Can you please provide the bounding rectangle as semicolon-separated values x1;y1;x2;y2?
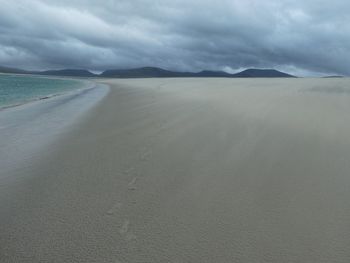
0;79;350;263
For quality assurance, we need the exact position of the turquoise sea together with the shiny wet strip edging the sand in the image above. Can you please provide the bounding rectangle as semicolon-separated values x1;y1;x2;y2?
0;75;109;182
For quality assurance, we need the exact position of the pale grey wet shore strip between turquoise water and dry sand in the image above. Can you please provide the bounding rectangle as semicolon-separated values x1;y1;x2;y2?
0;82;109;185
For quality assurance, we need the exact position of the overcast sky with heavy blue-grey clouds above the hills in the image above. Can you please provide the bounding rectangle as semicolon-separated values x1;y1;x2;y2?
0;0;350;75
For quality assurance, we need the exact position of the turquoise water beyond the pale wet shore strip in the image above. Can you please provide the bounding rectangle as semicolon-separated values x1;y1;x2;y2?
0;74;84;108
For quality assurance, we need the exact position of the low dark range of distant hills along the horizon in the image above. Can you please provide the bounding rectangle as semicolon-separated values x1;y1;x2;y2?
0;67;295;78
